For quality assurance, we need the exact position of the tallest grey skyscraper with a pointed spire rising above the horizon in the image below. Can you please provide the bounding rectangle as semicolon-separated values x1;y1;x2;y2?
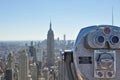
47;22;55;67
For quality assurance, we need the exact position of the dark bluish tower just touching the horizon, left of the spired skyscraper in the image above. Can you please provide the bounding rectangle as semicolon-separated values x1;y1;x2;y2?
29;41;37;63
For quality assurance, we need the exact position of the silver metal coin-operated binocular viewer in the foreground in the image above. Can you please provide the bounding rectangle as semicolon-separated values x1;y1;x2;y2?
64;25;120;80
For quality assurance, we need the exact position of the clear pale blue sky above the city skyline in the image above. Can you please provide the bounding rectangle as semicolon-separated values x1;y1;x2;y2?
0;0;120;41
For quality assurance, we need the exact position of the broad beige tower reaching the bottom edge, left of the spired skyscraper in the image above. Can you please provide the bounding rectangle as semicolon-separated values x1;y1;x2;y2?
19;50;29;80
